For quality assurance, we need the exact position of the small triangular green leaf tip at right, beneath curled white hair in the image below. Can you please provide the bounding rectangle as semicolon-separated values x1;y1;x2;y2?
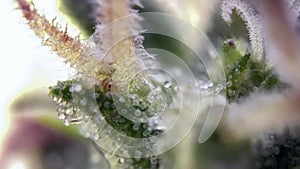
223;40;288;102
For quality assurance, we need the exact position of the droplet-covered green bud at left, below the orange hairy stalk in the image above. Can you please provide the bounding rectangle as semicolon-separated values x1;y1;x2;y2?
49;79;163;168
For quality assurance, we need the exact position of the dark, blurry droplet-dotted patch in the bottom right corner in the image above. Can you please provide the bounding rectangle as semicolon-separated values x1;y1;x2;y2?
252;126;300;169
